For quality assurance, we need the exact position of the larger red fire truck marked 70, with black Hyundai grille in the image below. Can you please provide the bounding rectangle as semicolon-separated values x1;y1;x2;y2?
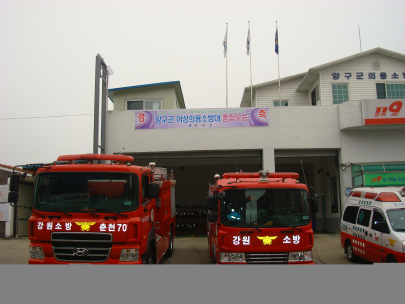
9;154;176;264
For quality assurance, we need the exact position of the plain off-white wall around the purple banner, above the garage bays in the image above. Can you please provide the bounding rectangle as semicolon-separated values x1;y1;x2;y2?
106;106;340;162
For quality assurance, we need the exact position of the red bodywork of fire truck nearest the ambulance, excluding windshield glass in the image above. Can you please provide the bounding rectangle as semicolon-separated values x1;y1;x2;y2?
207;172;314;264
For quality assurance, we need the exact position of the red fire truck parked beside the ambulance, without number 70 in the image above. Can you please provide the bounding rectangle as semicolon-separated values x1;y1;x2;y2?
207;171;314;264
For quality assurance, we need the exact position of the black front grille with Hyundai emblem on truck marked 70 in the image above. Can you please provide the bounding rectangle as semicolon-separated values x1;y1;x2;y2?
51;232;113;262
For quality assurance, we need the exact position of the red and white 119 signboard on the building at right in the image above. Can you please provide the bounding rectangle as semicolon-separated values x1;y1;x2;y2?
362;99;405;126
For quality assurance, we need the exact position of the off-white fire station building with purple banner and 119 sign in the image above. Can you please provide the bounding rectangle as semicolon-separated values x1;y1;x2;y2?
105;48;405;231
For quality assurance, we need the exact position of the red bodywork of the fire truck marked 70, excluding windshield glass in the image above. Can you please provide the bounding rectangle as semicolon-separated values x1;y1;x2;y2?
25;154;176;264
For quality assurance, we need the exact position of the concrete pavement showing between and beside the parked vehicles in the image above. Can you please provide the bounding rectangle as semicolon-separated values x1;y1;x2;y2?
0;233;360;264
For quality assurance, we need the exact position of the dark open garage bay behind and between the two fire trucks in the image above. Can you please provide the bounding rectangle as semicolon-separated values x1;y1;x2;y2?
124;150;262;235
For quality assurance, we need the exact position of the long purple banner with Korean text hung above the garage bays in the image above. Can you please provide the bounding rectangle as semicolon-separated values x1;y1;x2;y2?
135;108;269;129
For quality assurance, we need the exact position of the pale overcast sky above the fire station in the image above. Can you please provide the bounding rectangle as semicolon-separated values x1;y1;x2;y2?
0;0;405;166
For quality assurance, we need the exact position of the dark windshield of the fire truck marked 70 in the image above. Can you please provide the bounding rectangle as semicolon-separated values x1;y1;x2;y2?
34;172;139;213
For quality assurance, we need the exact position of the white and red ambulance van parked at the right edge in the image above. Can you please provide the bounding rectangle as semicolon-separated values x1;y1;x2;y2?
340;186;405;263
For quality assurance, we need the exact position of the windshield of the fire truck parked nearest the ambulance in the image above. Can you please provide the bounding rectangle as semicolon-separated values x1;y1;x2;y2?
220;189;311;228
